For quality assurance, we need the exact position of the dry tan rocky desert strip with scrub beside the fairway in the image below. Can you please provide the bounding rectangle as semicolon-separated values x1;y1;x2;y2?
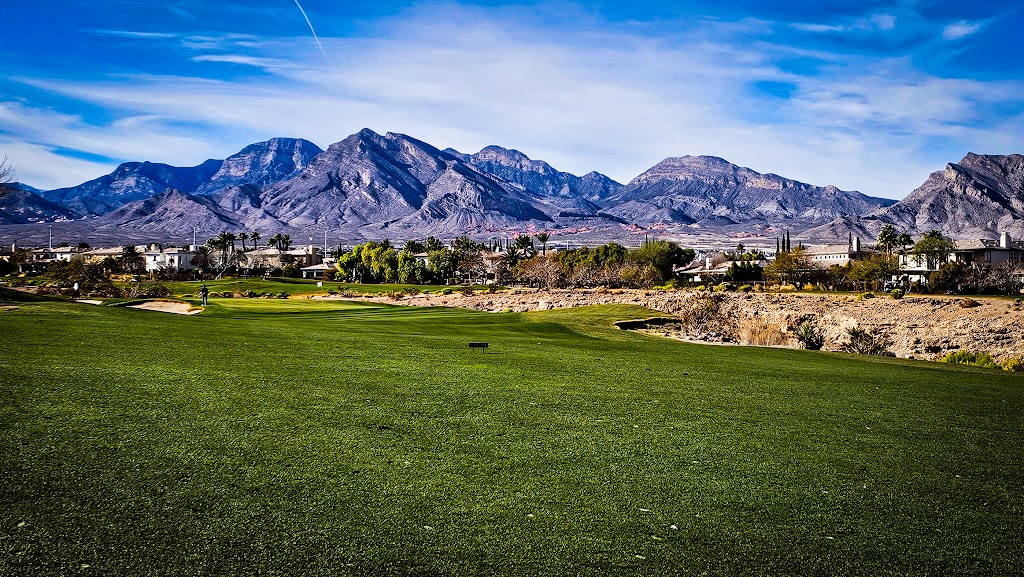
352;289;1024;361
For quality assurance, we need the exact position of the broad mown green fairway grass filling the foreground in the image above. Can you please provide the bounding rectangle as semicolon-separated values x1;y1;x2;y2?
0;295;1024;576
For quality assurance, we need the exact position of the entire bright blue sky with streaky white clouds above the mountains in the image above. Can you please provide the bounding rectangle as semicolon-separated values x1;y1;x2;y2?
0;0;1024;198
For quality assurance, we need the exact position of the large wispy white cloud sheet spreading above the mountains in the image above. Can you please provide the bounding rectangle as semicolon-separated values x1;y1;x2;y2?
6;5;1024;197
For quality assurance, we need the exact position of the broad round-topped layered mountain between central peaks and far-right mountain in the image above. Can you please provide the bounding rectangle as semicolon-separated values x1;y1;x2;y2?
607;156;894;231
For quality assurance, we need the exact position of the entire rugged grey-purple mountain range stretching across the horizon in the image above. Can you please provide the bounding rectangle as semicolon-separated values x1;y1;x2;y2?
0;129;1024;244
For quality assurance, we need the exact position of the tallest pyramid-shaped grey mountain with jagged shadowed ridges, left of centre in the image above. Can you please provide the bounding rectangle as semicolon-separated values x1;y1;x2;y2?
261;129;550;232
